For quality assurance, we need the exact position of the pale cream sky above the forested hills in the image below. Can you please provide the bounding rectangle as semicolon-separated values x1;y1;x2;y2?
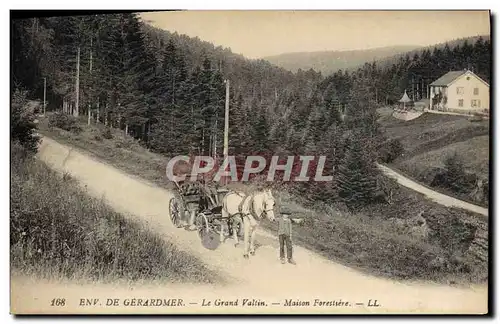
141;11;490;58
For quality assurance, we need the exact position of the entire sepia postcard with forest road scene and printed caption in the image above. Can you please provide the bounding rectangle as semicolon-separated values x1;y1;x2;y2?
10;10;492;315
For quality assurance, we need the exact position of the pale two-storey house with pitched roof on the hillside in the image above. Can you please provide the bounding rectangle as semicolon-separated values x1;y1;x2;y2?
429;70;490;113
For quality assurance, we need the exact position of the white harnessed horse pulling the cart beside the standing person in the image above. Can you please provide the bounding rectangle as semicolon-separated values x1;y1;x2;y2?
221;189;276;258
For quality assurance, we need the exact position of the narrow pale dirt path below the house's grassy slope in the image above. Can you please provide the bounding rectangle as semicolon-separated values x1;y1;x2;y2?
377;164;488;216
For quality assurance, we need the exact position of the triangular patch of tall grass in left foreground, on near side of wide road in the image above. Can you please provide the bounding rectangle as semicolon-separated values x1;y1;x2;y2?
10;145;220;283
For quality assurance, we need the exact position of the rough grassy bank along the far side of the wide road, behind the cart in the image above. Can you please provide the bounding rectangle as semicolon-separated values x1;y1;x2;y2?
38;116;488;284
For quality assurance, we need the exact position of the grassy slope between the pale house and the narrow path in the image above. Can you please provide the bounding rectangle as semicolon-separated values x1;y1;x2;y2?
379;113;489;206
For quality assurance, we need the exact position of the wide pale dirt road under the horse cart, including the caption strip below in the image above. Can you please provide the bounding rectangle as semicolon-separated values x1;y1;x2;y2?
11;138;487;314
